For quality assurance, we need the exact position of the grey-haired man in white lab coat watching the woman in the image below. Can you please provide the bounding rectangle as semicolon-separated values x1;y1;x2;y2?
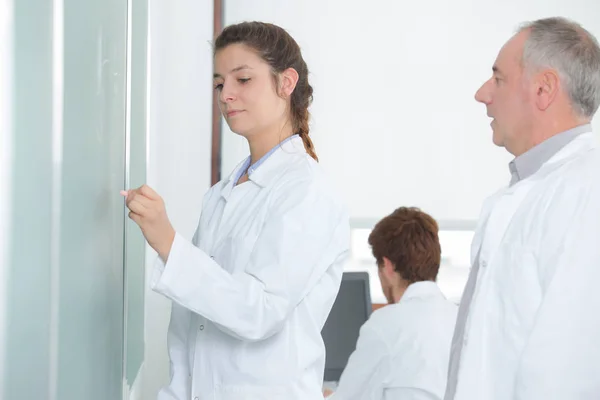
445;18;600;400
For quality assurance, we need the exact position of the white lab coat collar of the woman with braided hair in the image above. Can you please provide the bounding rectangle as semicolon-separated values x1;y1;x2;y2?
221;136;306;200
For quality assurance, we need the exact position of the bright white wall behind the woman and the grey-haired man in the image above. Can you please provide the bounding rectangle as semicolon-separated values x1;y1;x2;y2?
222;0;600;225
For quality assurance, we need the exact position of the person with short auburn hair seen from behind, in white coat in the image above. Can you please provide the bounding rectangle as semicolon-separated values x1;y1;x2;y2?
328;207;457;400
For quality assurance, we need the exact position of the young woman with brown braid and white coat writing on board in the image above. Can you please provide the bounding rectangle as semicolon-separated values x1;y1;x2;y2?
124;22;350;400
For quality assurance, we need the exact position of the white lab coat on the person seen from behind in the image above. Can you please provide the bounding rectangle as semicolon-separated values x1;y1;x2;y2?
328;282;458;400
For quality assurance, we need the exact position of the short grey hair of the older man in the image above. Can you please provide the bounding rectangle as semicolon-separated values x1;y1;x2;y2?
519;17;600;119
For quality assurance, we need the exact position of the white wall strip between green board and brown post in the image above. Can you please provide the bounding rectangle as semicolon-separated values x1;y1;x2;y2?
142;0;213;400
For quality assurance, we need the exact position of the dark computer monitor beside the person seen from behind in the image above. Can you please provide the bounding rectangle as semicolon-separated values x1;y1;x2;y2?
321;272;372;382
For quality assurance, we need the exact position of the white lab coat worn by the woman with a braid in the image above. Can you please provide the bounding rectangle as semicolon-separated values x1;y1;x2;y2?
152;138;350;400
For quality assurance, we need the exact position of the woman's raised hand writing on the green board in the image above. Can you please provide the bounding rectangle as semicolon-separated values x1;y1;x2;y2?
121;185;175;262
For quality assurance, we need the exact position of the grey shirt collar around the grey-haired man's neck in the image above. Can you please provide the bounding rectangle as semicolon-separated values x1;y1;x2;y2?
508;124;592;186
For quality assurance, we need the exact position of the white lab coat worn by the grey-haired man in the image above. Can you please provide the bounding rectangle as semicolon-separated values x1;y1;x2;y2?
454;133;600;400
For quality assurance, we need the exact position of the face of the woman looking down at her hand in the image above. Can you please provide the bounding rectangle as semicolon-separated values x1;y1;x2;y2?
213;44;287;138
